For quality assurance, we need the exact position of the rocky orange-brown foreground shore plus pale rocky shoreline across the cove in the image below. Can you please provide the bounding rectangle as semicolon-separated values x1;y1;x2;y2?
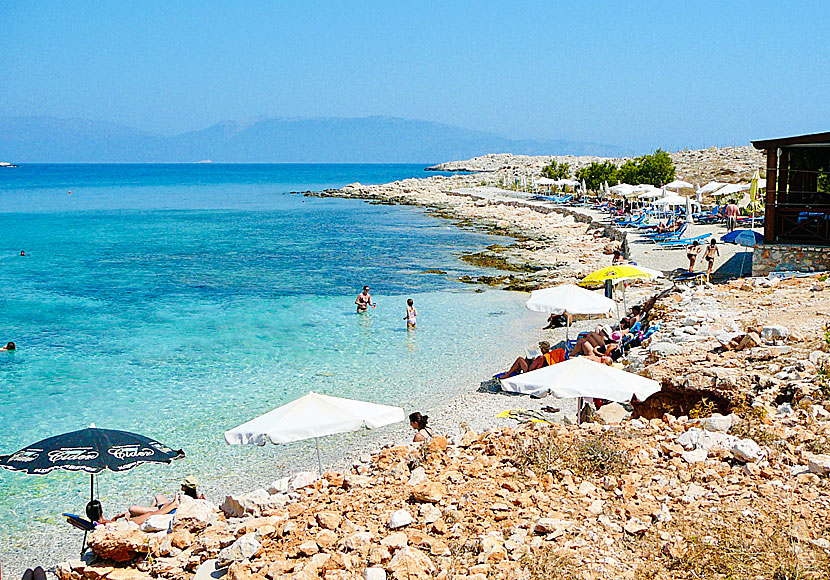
40;154;830;580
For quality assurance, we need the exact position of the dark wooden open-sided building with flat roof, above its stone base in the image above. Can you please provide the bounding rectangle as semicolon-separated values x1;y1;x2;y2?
752;132;830;246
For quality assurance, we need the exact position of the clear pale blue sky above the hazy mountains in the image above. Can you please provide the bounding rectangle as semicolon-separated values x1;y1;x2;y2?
0;0;830;150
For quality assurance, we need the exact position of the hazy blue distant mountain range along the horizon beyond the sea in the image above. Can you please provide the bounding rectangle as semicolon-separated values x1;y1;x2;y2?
0;117;631;164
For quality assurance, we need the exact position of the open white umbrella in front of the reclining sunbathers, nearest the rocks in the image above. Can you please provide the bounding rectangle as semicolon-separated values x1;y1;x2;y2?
501;356;660;403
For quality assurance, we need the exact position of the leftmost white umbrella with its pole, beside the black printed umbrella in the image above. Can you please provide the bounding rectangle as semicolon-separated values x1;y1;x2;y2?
225;392;404;474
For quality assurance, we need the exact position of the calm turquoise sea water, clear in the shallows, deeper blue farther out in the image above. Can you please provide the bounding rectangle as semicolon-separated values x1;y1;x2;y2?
0;165;539;565
